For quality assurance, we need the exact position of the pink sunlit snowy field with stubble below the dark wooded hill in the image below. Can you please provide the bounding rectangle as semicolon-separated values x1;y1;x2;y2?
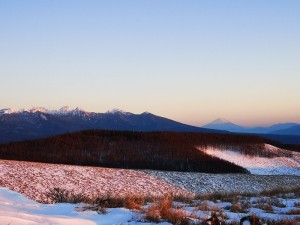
0;160;189;203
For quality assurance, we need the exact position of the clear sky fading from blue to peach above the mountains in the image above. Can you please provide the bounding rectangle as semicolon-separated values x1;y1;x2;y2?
0;0;300;126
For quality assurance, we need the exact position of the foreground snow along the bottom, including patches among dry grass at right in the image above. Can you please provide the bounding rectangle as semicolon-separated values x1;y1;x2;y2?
0;188;300;225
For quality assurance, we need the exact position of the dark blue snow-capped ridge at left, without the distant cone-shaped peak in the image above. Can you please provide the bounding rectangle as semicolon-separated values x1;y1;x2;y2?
0;106;216;143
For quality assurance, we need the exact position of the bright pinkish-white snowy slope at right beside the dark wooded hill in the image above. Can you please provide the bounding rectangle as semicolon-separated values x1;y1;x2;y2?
199;144;300;176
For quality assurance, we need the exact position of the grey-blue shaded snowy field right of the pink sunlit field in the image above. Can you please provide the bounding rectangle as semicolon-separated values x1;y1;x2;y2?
145;170;300;194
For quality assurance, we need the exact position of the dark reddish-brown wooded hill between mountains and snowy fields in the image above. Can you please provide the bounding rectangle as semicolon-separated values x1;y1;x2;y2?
0;130;280;173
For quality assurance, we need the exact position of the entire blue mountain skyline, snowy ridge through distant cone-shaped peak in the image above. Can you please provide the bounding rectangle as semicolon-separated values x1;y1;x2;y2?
0;106;300;144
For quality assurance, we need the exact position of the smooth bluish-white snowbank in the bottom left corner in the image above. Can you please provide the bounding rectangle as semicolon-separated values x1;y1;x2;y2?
0;187;170;225
